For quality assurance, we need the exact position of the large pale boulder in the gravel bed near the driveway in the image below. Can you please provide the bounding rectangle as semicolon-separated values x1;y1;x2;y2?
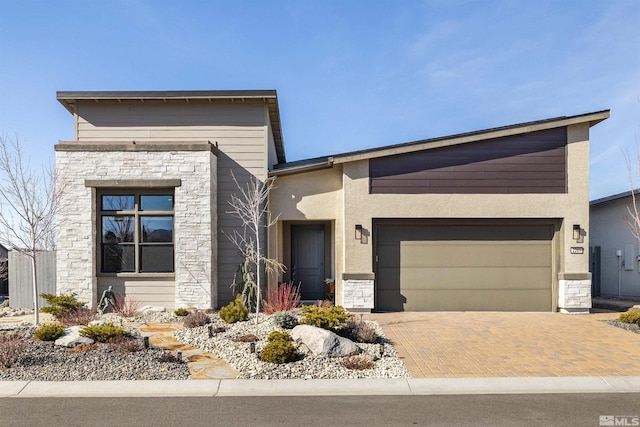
291;325;362;357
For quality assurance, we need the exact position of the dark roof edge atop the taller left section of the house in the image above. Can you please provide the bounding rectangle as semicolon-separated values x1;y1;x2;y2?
56;89;287;163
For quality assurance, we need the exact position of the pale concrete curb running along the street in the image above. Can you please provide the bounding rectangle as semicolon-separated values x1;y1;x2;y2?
0;377;640;398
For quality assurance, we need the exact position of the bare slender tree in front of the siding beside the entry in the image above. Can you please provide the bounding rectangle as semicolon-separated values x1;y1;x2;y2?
225;173;284;324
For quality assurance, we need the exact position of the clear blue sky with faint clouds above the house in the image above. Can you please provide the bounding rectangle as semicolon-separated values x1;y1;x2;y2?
0;0;640;198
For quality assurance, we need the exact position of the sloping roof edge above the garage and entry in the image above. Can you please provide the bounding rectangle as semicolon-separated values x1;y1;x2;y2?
271;110;610;176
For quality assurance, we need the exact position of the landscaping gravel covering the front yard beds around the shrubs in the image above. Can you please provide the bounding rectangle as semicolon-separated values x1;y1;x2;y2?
0;312;409;381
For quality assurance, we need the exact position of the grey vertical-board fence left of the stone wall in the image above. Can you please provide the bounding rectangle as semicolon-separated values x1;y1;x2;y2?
9;251;56;308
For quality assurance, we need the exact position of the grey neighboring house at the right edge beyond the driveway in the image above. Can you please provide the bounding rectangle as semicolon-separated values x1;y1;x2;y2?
589;189;640;299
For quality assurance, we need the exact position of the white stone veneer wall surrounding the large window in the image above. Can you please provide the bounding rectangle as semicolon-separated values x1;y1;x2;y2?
56;149;218;308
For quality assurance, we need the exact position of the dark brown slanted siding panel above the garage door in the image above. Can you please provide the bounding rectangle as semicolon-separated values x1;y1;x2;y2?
369;127;567;194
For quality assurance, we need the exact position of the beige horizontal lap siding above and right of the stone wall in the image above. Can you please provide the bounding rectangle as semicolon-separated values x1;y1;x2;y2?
77;101;275;306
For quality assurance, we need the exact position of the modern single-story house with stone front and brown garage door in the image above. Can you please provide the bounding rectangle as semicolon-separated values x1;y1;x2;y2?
56;91;609;312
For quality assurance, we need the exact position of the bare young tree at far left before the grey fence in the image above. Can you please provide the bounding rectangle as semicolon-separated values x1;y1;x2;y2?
0;137;61;325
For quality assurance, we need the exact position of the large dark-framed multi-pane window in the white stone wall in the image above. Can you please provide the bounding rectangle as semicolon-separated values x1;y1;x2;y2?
98;190;174;273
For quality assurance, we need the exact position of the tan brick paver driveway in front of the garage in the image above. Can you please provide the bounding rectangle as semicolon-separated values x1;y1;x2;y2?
365;312;640;378
